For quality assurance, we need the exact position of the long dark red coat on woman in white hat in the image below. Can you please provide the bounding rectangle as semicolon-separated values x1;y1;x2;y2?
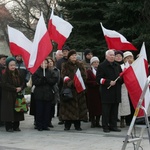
86;69;102;116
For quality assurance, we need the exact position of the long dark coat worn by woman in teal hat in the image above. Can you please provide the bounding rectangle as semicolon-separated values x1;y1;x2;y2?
1;69;24;122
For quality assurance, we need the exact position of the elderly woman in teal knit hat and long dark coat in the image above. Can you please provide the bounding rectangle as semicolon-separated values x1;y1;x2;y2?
1;57;25;132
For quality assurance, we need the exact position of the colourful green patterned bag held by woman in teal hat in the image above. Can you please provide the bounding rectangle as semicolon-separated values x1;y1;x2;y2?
15;93;28;112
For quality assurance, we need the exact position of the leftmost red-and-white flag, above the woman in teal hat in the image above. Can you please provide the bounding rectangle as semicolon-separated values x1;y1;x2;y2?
8;26;32;68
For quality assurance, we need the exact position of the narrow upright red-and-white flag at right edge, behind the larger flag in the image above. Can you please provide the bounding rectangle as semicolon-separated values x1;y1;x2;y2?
139;42;149;76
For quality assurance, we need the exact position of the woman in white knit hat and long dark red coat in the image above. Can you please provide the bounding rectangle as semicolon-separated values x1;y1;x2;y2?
86;56;102;128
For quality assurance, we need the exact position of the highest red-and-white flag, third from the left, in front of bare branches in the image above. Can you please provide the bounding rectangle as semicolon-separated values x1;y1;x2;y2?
48;9;73;49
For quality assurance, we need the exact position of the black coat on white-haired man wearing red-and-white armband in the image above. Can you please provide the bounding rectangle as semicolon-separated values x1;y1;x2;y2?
96;60;122;103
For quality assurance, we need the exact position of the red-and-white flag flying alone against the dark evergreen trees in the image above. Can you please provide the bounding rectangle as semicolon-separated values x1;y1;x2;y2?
100;23;137;50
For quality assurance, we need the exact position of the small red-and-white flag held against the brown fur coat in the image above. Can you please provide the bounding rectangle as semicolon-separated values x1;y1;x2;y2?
74;69;86;93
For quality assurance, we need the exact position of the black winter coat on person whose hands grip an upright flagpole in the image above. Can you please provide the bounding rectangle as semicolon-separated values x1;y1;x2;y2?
32;67;57;101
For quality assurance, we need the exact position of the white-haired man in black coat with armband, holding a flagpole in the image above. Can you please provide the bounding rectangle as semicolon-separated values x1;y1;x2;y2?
96;50;122;132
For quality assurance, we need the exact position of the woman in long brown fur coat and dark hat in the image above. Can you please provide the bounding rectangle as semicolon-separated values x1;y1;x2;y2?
60;50;87;131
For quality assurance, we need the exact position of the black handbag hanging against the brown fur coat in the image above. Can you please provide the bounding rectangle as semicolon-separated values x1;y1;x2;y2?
60;87;73;102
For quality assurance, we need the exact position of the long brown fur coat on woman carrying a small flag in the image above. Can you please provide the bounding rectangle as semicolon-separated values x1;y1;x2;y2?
60;60;87;120
